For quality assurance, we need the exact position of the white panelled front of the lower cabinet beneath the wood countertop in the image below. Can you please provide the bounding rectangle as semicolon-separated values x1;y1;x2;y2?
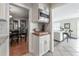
39;35;50;55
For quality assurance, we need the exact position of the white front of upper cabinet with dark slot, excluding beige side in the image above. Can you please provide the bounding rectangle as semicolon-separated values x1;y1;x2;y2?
38;3;49;23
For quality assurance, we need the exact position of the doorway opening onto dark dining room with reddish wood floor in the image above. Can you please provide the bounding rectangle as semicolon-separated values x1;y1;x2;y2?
9;4;29;56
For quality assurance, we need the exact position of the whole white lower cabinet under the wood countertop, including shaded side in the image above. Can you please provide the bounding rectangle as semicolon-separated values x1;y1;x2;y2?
32;34;50;56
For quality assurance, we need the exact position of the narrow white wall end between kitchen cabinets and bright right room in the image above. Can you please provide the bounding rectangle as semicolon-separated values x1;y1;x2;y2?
50;6;54;52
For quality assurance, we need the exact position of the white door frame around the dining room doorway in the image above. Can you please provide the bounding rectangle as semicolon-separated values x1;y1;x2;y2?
8;3;32;54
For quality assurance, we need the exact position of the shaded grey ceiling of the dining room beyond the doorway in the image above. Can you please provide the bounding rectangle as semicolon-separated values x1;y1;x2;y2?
10;5;28;18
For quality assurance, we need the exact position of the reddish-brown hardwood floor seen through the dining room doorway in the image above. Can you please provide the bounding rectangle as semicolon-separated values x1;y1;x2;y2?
10;39;29;56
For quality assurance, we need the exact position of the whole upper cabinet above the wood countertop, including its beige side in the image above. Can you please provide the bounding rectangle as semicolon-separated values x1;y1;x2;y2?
32;3;49;23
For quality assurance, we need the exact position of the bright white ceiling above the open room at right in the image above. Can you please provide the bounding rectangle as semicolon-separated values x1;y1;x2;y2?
52;3;79;21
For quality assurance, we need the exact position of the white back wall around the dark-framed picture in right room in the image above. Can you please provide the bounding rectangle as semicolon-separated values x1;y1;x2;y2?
60;19;77;37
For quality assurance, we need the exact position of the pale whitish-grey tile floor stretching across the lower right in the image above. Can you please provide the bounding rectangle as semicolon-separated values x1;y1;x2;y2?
27;39;79;56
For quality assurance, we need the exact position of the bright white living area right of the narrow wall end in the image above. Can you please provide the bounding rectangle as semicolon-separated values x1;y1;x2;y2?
53;4;79;56
